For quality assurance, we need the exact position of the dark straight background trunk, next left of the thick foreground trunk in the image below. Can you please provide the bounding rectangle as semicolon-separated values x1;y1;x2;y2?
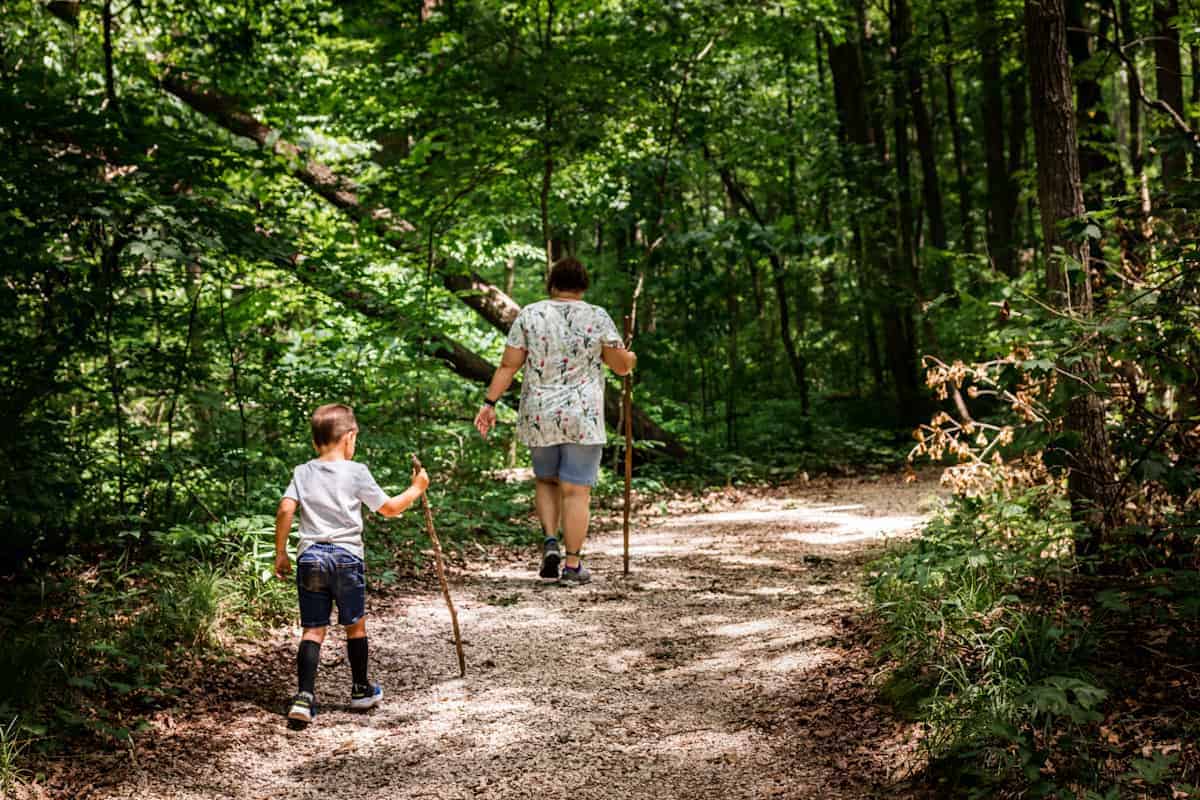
976;0;1019;277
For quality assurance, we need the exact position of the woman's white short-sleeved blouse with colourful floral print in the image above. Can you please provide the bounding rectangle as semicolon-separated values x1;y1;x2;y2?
508;300;622;447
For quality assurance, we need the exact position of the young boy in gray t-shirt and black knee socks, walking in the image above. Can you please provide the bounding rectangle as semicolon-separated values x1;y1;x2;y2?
275;403;430;723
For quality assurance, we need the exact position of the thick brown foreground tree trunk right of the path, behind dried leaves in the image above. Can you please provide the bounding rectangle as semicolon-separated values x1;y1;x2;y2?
1025;0;1116;553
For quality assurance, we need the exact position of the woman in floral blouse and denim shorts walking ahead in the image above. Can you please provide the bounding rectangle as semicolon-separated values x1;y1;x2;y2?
475;257;637;584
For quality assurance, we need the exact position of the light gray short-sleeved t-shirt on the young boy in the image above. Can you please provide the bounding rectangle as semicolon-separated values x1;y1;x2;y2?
283;458;388;558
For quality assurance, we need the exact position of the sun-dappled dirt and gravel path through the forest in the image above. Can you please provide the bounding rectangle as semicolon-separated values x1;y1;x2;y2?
90;476;934;800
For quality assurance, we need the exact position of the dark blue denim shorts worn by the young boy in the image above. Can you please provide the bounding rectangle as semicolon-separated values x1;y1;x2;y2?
296;543;367;627
